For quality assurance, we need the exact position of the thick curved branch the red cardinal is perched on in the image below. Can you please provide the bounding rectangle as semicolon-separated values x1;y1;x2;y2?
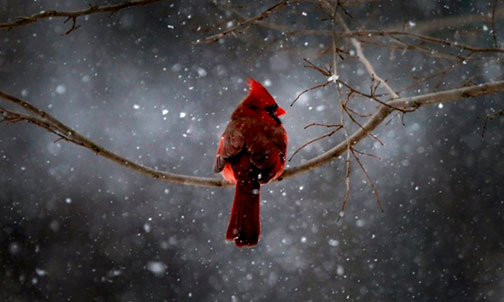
0;81;504;187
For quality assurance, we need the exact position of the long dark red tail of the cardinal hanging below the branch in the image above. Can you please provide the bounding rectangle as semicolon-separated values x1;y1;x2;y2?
226;180;261;247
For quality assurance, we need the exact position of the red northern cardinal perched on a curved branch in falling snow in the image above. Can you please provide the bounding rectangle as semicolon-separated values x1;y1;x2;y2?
214;78;287;247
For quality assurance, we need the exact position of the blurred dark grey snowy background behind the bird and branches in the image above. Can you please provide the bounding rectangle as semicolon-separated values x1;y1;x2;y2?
0;0;504;301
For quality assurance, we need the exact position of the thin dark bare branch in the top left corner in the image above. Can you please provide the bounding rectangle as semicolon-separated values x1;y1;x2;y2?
0;0;163;34
